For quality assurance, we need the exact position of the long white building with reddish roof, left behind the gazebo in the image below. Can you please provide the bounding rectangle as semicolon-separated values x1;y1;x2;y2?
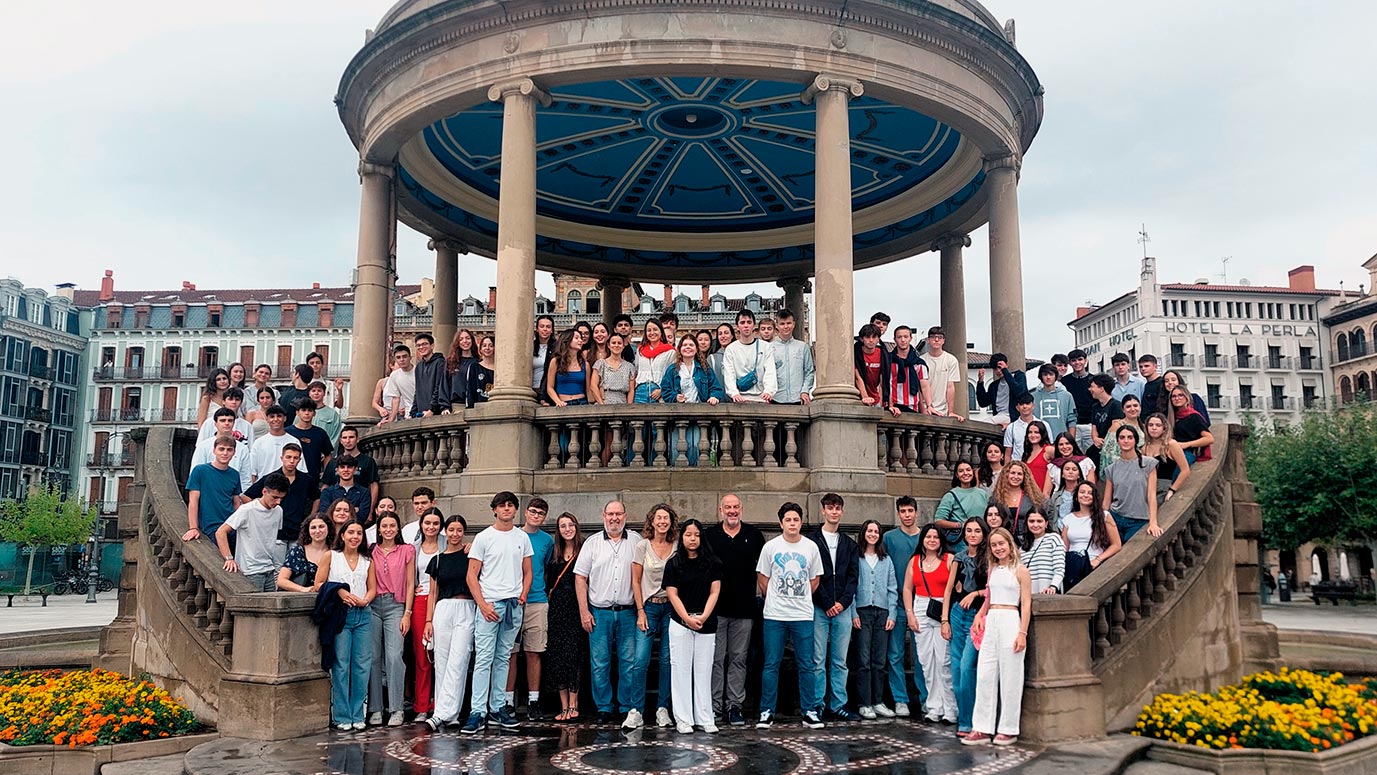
74;270;363;513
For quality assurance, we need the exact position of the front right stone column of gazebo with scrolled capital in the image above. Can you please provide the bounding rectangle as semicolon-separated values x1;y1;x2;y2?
803;74;862;401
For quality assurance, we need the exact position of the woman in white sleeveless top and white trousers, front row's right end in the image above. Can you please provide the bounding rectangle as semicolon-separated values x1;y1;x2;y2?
961;527;1033;745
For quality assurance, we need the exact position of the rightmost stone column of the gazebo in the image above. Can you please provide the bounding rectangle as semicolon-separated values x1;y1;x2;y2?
985;153;1027;369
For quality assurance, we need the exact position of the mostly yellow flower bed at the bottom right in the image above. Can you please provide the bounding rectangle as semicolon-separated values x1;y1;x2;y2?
1133;668;1377;753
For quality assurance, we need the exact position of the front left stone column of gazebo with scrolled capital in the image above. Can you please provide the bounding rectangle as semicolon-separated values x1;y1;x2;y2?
487;78;549;403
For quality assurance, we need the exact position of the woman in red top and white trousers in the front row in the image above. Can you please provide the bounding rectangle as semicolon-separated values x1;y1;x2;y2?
903;524;957;724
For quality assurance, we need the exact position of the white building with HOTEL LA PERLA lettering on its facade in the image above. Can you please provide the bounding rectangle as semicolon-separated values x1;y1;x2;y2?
1067;257;1340;423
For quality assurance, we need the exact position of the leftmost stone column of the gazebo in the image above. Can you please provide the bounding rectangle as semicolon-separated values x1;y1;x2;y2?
348;161;394;423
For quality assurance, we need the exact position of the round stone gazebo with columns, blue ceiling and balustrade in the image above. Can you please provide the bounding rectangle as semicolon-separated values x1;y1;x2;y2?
336;0;1042;515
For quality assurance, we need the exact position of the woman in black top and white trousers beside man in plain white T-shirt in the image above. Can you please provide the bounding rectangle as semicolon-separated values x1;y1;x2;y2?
425;513;478;731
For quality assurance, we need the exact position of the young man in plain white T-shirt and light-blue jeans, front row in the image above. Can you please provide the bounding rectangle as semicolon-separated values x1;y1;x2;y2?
460;491;532;735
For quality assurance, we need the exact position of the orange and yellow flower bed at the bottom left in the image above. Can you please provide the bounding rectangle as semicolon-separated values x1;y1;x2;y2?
0;670;200;747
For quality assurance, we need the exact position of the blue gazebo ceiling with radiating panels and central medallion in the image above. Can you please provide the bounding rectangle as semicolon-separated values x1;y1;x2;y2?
398;76;985;274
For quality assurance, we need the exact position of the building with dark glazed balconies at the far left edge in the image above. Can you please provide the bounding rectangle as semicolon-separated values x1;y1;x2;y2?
0;278;87;500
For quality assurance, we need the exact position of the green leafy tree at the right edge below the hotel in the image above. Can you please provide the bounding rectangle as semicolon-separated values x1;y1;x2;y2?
1246;405;1377;549
